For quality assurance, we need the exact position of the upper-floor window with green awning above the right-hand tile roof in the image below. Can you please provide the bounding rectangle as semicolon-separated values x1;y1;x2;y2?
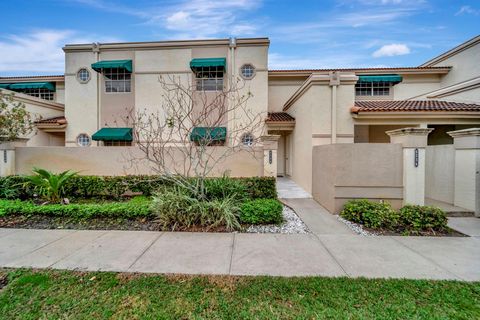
355;74;402;97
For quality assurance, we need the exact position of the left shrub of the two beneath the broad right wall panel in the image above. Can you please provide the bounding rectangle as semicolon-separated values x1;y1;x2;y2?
340;199;398;229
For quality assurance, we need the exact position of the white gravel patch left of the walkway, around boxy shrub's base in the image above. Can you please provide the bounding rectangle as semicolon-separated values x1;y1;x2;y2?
245;205;310;234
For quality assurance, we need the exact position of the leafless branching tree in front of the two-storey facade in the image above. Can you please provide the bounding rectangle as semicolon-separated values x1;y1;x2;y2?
125;76;266;199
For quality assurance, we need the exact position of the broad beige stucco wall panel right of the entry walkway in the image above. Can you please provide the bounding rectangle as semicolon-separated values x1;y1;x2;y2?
312;143;403;213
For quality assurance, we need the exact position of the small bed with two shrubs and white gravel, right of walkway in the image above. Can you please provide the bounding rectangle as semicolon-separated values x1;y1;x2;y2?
339;199;465;237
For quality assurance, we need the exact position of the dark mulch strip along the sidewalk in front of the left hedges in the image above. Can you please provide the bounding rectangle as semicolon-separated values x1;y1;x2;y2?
0;215;233;232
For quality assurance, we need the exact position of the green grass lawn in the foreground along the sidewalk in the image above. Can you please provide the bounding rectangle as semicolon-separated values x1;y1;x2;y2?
0;270;480;319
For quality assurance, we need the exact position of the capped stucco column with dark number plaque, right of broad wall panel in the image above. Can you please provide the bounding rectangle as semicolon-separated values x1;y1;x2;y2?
386;128;433;206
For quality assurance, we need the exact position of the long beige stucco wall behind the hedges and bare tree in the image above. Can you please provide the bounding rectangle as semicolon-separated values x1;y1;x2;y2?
15;147;263;177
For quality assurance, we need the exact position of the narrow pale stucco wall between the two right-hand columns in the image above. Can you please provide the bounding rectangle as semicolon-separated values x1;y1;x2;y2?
425;145;455;204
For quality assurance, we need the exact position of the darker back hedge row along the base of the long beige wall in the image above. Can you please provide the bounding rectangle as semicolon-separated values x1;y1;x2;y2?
0;176;277;200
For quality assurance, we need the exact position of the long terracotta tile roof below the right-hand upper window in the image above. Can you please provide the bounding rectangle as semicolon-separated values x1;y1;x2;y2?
351;100;480;113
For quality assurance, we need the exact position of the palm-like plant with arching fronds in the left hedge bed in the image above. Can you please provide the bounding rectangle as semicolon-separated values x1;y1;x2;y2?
29;168;77;203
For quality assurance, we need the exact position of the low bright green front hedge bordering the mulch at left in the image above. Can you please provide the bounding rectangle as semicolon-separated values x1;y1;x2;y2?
0;197;151;219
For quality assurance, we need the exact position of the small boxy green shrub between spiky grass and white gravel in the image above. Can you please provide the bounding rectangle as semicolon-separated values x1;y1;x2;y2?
240;199;283;224
